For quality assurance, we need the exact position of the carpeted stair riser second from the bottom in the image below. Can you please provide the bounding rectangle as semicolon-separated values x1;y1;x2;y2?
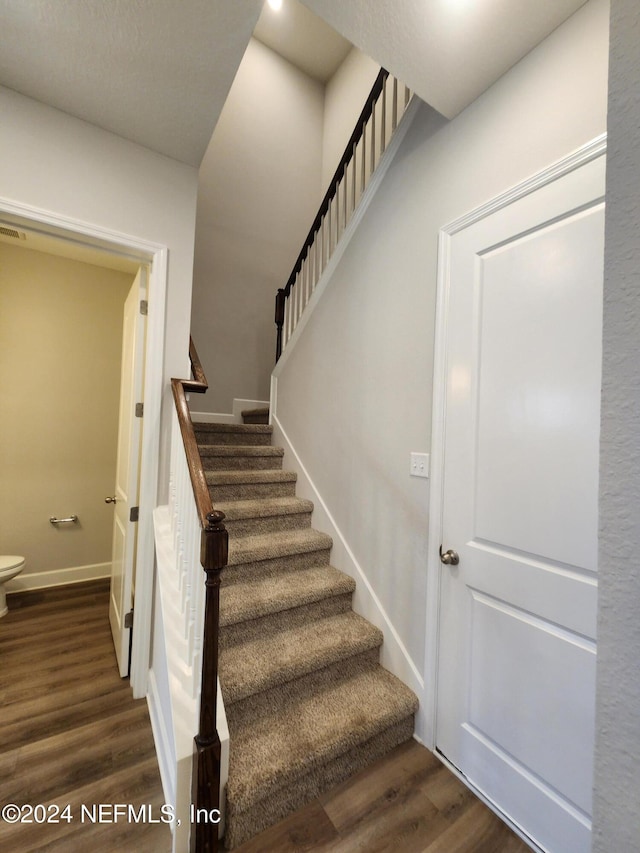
221;641;382;712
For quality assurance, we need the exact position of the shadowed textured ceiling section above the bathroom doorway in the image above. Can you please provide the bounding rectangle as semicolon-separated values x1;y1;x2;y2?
0;0;262;166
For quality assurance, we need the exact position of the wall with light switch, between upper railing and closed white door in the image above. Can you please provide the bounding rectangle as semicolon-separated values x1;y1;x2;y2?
277;0;608;734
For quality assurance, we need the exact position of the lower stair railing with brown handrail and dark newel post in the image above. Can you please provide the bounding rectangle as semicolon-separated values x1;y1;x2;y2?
171;341;228;853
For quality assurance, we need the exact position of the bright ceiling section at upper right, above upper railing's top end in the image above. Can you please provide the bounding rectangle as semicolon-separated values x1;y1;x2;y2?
300;0;586;118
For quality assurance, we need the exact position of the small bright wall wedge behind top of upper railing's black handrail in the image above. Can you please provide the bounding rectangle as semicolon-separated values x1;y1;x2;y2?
320;47;380;189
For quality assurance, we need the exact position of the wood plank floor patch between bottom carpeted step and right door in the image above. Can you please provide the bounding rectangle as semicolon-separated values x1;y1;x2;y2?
234;741;531;853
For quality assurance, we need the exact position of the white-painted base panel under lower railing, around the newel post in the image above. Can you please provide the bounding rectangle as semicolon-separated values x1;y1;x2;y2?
147;506;229;853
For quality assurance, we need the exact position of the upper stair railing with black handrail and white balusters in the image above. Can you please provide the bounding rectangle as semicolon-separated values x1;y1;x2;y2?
275;68;412;361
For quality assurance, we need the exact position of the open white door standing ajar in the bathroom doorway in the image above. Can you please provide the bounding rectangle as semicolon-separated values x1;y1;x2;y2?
109;267;147;678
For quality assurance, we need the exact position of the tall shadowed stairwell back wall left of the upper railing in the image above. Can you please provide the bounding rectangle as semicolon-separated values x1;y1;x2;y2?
192;39;324;413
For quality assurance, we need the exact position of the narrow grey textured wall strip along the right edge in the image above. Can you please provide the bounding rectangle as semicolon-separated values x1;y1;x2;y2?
593;0;640;853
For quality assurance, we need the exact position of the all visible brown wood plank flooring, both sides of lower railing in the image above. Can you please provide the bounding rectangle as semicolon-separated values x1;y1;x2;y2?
0;582;529;853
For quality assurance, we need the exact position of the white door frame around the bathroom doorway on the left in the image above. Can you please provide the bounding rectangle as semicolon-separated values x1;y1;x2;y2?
0;197;168;699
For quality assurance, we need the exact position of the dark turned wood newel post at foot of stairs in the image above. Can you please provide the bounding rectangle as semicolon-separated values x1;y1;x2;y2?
191;510;229;853
